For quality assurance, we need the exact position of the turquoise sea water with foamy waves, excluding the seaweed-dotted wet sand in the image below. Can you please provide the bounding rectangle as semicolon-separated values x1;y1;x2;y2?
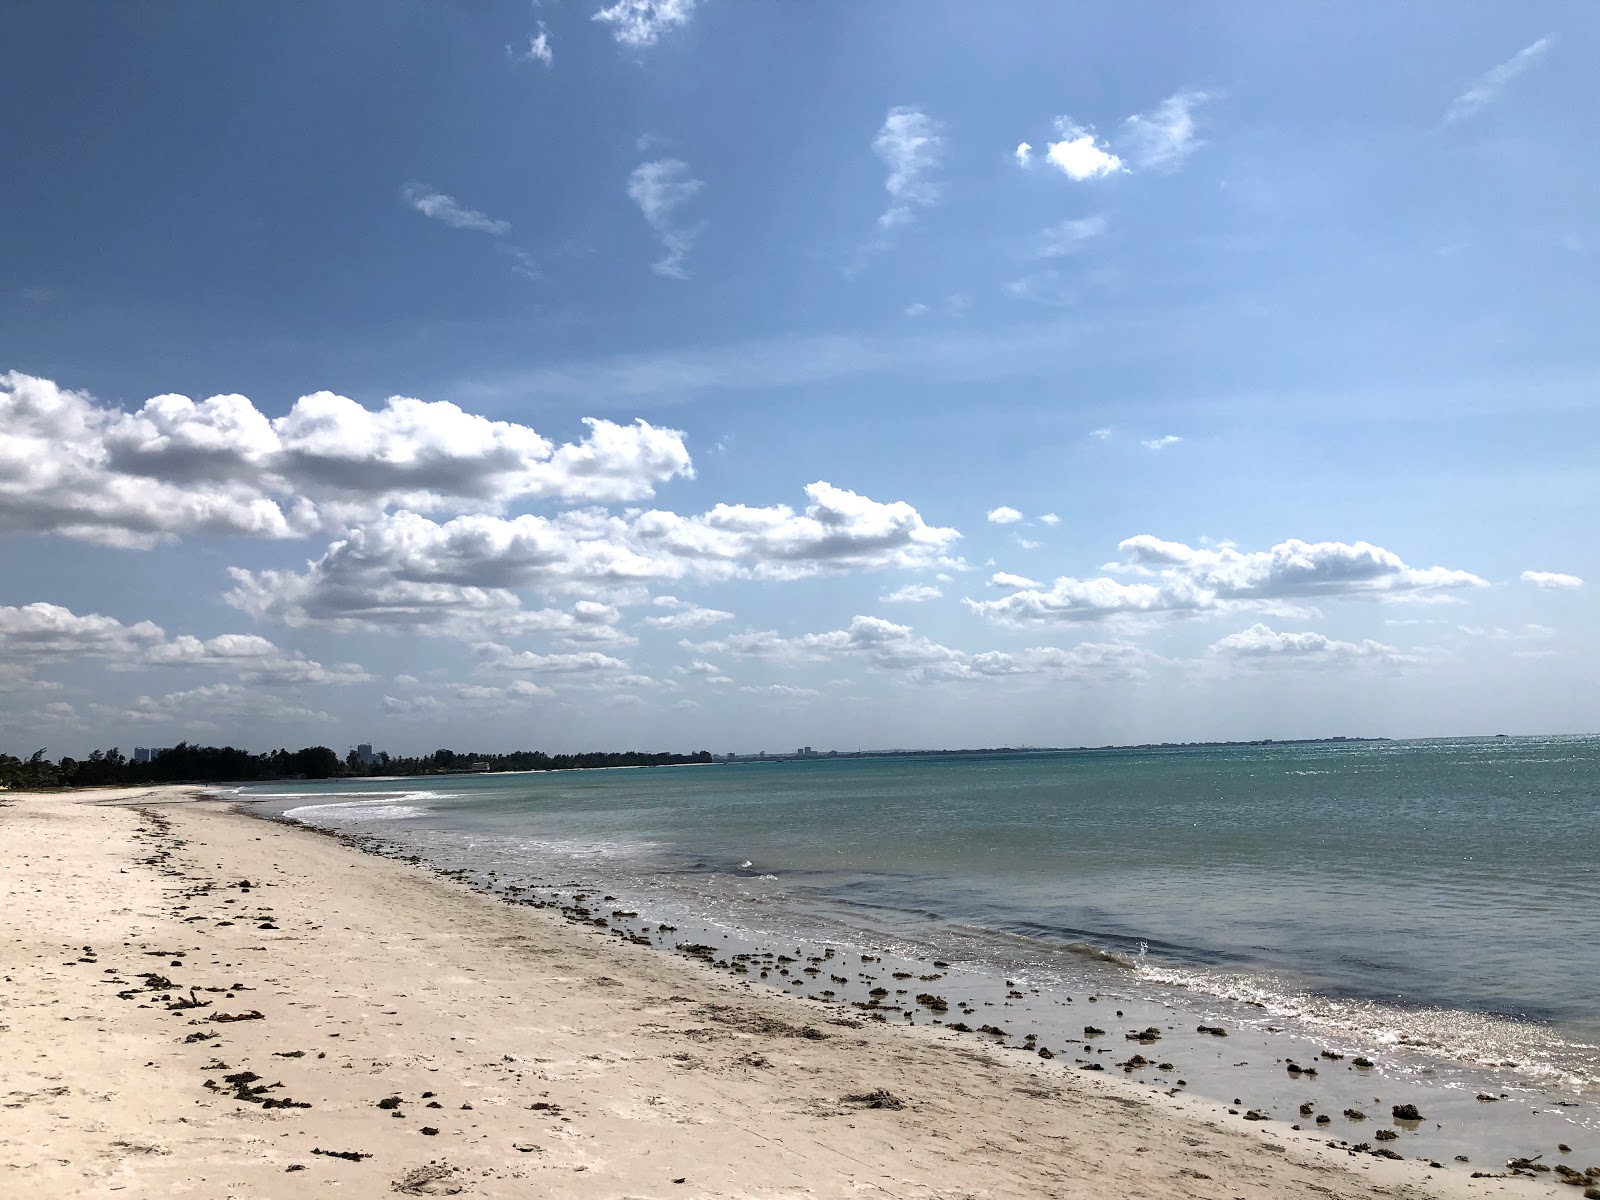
240;738;1600;1094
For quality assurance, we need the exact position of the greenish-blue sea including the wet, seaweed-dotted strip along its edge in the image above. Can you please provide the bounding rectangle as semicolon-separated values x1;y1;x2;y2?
238;738;1600;1171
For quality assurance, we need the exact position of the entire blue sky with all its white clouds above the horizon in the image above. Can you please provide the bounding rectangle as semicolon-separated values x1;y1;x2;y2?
0;0;1600;757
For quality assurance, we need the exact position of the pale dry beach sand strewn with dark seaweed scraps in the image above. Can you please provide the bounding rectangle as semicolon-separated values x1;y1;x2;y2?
0;789;1555;1200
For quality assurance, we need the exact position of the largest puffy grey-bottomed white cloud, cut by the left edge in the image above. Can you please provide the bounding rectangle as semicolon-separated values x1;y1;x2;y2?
0;371;694;547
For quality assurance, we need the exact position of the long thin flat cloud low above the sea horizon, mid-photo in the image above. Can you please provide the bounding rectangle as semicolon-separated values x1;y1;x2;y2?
696;616;1162;683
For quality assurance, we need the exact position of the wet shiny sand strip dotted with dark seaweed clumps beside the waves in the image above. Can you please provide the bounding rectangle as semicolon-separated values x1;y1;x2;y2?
256;784;1600;1173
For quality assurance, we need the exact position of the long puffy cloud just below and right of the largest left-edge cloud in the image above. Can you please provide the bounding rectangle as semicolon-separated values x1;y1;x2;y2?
227;482;960;634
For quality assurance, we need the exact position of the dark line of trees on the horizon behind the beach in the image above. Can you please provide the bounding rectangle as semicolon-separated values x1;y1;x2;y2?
0;742;712;790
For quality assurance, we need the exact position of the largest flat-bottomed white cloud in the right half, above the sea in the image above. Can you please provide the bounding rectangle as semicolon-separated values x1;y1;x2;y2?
965;534;1486;624
